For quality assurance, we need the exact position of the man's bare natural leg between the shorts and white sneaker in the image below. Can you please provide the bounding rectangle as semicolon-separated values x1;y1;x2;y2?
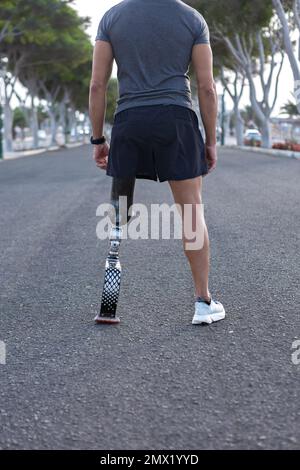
169;176;210;301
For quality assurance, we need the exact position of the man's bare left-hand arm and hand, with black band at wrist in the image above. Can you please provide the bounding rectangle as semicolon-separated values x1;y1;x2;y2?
89;41;114;169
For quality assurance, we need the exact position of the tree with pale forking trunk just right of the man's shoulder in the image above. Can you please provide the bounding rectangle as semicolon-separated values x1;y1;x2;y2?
188;0;284;147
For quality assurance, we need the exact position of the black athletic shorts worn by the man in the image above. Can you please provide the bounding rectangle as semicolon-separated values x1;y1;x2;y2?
107;105;208;182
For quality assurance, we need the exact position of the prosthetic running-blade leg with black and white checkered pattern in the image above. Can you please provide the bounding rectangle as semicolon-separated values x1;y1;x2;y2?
95;178;135;324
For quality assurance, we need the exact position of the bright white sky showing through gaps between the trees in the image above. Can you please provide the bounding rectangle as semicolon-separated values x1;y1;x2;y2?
69;0;293;115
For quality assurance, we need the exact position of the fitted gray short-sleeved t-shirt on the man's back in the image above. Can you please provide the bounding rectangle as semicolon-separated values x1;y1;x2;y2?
96;0;209;114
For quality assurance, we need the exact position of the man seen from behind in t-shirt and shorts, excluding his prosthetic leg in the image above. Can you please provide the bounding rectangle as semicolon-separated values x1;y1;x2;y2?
90;0;225;324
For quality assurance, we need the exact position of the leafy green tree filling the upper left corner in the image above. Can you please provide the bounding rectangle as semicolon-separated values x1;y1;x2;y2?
0;0;91;147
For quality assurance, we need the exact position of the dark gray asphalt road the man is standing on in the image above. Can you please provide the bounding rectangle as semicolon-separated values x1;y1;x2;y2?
0;146;300;450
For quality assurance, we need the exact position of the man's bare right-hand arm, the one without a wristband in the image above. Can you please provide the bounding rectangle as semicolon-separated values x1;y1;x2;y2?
192;44;218;171
